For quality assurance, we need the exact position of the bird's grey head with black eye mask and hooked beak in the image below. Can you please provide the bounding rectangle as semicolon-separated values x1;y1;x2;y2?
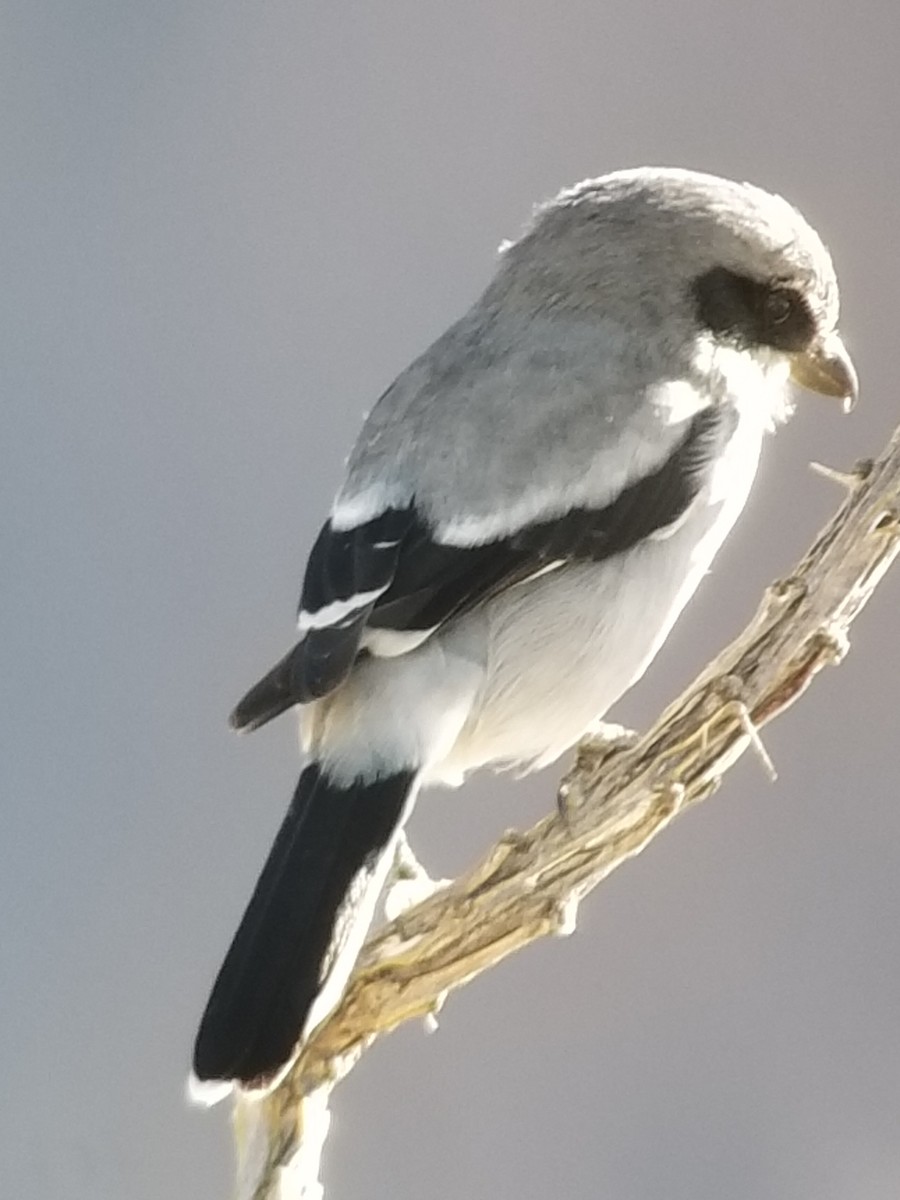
499;168;857;409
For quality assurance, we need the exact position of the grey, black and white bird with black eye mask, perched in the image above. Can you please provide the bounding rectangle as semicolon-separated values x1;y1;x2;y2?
191;167;858;1103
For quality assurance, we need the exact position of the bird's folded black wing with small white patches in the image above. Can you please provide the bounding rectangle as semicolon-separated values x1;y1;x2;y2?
232;408;733;730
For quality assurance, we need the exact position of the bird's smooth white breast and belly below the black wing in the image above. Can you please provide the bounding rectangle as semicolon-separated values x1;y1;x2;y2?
428;374;782;781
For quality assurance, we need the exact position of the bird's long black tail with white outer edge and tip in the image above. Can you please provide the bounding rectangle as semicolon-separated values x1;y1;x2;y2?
193;764;415;1088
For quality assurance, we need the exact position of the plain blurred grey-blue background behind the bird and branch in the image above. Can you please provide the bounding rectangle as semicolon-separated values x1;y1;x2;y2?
0;0;900;1200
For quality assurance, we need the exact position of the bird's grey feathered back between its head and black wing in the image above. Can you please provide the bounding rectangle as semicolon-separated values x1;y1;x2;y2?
332;311;706;540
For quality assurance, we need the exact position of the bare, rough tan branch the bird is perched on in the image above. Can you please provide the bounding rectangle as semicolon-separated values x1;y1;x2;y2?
234;430;900;1200
